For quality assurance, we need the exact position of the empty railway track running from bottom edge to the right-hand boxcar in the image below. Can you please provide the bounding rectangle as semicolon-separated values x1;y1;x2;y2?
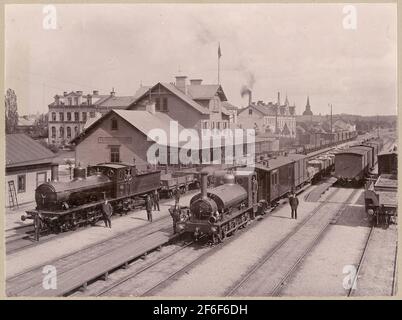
225;189;357;296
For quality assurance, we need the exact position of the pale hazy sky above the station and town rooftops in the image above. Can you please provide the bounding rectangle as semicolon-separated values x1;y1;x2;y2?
5;4;397;115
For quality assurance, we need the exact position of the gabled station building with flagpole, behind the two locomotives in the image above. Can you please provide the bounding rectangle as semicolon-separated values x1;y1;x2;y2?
72;76;251;169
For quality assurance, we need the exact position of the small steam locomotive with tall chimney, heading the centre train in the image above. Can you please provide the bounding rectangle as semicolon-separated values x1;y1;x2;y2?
176;171;257;243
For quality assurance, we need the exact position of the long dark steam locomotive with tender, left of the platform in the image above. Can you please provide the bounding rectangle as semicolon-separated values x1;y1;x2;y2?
21;163;160;236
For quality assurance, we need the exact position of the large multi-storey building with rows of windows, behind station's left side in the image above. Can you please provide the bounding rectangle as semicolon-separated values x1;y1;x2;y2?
48;90;135;145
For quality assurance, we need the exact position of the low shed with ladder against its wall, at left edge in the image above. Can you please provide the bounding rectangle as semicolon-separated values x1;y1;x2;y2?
5;133;58;206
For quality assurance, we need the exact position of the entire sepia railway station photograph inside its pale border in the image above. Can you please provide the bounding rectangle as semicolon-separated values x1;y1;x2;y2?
4;3;398;299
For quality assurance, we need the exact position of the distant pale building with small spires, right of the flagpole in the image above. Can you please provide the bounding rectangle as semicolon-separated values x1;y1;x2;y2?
237;92;296;138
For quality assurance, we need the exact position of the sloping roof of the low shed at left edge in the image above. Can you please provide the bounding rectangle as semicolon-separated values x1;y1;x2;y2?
6;133;55;168
